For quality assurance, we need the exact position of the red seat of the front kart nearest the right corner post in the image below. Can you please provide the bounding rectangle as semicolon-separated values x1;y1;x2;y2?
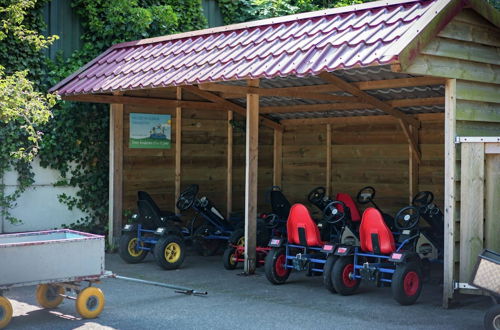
359;207;396;254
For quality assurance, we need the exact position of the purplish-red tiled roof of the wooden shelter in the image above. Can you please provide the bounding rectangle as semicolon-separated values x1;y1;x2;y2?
52;0;442;95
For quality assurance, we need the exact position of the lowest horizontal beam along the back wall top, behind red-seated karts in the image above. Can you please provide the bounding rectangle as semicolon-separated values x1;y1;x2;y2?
281;113;444;127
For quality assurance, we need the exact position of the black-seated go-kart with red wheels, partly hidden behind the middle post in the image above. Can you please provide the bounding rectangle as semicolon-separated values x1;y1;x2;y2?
222;186;291;270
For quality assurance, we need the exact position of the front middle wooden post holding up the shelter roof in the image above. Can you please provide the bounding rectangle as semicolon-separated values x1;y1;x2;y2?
244;80;259;274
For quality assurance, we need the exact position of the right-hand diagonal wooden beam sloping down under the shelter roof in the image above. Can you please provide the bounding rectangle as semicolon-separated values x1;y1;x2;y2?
319;72;419;127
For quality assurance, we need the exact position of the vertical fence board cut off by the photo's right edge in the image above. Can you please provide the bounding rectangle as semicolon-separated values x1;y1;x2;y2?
484;153;500;251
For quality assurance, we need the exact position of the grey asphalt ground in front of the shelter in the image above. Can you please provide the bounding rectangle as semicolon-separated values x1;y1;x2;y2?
2;254;489;330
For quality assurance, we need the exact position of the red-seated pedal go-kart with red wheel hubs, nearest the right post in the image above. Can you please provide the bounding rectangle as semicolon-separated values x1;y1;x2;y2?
331;206;422;305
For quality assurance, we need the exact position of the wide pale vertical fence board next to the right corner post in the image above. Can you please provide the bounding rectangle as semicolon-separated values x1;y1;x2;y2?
459;142;482;282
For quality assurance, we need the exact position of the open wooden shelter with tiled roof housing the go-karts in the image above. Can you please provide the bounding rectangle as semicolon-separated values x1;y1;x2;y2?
52;0;500;306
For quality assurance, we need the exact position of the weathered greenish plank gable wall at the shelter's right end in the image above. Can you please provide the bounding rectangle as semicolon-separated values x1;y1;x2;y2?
405;9;500;298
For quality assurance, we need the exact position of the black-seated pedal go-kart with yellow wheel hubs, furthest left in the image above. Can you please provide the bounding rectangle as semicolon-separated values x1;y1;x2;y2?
119;191;189;269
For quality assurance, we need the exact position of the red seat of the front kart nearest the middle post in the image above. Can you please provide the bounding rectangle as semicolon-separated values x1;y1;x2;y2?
286;204;325;246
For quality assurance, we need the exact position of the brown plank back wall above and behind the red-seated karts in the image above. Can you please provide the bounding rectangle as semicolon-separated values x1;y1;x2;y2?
283;114;444;218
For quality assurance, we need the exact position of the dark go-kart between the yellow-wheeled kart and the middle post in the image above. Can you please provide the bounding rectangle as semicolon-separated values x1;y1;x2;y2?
176;184;269;256
